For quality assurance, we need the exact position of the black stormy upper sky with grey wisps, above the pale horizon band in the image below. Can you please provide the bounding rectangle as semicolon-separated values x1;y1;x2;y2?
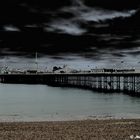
0;0;140;59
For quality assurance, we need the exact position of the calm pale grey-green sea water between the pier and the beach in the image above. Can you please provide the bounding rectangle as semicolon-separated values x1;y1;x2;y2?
0;84;140;121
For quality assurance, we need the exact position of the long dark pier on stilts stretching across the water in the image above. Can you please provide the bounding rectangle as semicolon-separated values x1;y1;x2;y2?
0;69;140;96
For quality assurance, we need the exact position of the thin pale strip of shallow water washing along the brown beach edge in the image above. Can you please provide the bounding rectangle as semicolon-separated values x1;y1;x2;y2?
0;115;140;123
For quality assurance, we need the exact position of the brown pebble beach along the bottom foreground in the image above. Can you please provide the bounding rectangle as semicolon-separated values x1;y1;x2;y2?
0;119;140;140
